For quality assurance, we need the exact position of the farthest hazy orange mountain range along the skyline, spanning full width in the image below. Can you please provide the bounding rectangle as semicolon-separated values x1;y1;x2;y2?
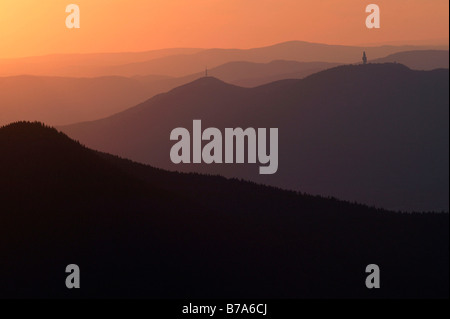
0;41;448;77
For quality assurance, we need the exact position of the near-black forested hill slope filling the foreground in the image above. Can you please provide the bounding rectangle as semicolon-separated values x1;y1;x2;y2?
0;122;449;298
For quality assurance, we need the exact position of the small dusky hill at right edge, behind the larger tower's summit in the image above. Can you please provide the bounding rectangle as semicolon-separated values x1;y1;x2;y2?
370;50;449;70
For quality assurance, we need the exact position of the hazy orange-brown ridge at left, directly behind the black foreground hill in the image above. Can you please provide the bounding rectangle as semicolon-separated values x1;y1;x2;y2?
0;76;166;125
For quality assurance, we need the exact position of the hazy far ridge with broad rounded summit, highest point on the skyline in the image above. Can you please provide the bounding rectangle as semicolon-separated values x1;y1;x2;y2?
105;41;448;77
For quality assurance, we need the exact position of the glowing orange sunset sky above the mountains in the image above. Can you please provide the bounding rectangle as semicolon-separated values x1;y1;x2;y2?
0;0;449;58
